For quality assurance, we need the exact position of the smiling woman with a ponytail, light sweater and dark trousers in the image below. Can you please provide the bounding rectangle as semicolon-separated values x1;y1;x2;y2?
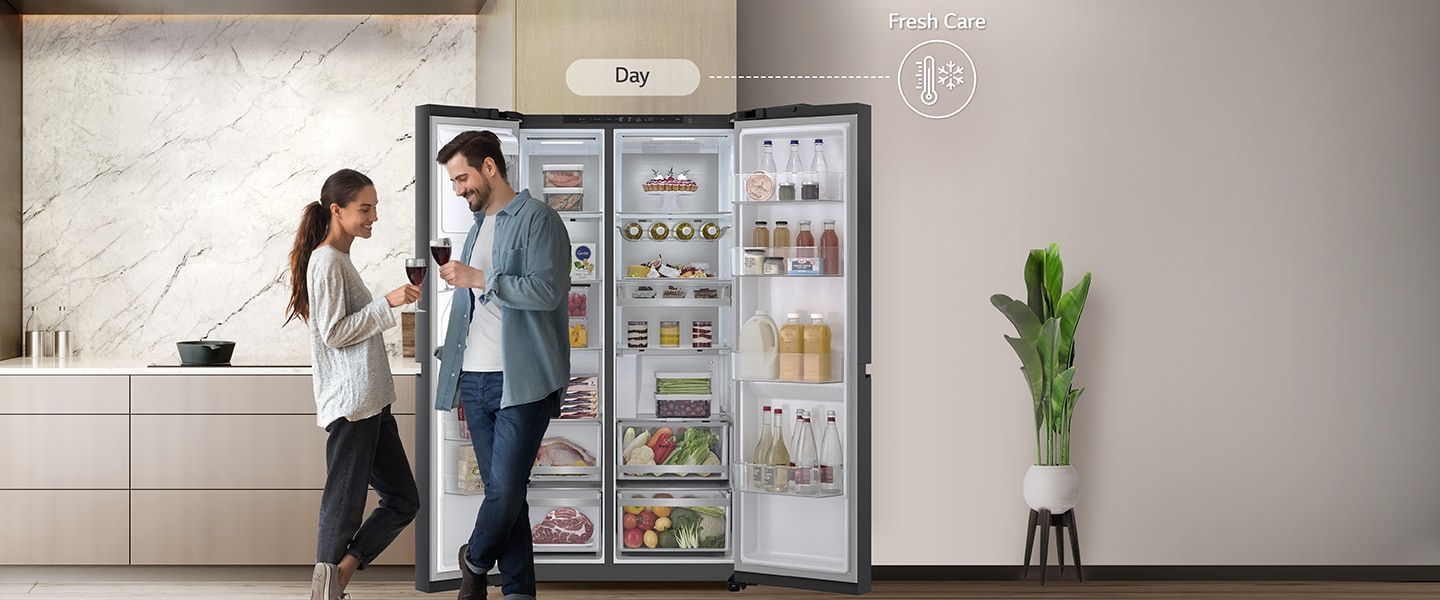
285;168;420;600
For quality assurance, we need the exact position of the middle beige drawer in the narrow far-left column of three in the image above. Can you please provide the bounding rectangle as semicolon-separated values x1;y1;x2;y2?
0;414;130;489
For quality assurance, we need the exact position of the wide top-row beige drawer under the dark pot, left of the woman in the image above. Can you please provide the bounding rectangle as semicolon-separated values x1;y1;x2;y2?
130;376;315;414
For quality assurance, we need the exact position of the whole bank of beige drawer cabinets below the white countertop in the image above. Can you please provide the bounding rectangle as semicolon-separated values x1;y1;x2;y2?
0;374;416;564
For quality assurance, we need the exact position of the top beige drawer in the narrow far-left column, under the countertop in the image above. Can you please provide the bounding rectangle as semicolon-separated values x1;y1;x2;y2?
0;376;130;414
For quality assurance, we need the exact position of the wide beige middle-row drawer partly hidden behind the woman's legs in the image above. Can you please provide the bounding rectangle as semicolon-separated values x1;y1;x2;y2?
130;414;415;489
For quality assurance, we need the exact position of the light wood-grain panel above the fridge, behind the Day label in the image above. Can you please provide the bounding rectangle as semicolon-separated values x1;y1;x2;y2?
515;0;736;114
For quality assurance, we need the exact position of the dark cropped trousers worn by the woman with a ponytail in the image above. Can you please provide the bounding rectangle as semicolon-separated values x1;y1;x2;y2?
315;406;420;568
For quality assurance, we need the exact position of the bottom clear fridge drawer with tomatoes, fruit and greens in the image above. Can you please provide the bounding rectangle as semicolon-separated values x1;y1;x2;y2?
615;488;730;558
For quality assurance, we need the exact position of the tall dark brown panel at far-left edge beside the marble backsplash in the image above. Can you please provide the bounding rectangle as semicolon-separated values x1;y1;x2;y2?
0;1;22;358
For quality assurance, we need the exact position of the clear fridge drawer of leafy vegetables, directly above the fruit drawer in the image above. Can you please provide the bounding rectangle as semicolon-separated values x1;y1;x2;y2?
615;420;730;481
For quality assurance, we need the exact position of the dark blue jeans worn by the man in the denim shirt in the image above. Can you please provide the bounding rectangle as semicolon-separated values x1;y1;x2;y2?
459;371;564;596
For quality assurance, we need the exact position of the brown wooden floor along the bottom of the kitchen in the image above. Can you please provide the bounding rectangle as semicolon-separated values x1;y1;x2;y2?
0;581;1440;600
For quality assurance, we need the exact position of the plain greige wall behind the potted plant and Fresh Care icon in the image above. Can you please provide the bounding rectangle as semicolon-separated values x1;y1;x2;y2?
739;0;1440;565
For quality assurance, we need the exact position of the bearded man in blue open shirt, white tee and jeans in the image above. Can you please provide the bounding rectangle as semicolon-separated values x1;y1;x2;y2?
435;131;570;600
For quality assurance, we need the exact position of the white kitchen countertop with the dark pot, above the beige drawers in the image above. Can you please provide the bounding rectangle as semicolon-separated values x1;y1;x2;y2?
0;357;420;376
